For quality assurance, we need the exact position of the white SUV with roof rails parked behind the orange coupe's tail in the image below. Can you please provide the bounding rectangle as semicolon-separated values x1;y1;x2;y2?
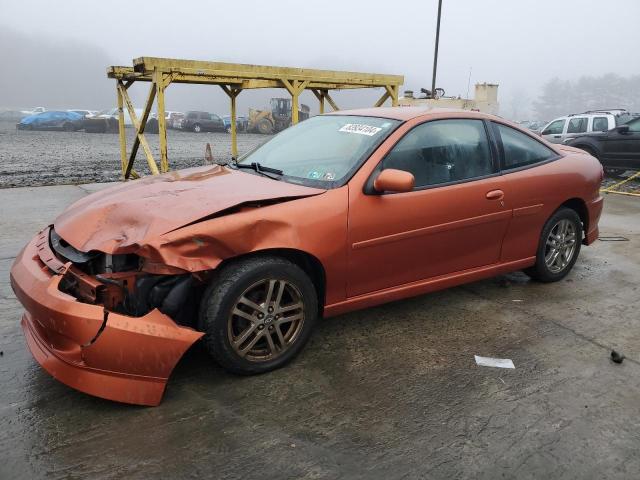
540;109;632;143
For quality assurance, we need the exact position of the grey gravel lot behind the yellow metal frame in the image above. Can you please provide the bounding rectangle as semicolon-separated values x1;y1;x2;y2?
0;122;270;188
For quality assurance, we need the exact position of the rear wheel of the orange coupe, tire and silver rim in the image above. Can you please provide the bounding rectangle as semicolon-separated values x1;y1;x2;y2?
524;207;582;283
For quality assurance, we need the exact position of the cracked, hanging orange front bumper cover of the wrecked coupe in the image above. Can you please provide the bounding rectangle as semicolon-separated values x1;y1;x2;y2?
11;229;203;405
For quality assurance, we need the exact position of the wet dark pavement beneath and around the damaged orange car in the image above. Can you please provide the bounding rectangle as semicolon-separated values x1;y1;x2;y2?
0;182;640;480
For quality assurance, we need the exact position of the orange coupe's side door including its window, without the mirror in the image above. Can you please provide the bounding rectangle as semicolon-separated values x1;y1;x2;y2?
347;119;511;296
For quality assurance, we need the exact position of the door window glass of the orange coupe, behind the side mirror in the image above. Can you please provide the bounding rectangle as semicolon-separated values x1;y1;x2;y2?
382;119;495;188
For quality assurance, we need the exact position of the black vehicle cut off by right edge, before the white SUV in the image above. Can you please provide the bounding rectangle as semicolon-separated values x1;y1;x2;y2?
567;116;640;175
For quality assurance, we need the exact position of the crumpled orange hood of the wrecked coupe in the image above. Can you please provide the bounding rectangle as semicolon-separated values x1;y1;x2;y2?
54;165;324;253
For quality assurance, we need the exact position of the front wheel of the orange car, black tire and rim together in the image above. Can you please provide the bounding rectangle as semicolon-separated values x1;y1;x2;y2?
198;256;318;375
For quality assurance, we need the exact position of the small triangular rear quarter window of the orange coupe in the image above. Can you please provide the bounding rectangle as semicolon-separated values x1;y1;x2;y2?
494;123;557;170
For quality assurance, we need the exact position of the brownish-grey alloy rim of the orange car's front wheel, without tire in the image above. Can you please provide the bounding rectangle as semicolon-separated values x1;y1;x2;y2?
227;278;304;362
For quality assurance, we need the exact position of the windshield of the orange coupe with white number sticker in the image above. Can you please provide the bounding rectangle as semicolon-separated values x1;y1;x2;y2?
238;115;400;188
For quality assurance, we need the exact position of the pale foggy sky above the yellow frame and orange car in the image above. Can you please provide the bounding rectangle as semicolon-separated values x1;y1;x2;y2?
0;0;640;118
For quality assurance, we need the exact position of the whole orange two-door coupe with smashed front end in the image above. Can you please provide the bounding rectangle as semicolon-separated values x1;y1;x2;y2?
11;108;603;405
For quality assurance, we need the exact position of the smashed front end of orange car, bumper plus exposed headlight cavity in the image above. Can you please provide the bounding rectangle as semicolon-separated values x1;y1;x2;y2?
11;227;204;405
